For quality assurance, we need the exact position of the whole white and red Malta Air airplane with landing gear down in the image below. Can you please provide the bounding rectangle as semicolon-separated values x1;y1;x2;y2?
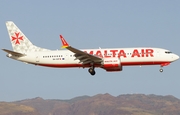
2;21;179;75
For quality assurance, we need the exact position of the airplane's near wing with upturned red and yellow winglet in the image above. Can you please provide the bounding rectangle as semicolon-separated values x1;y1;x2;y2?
60;35;103;64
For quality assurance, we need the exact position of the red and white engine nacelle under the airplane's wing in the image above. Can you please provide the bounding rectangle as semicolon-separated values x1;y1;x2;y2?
102;58;122;72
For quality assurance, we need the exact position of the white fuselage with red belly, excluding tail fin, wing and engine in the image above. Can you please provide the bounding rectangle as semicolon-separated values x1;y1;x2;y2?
8;47;179;68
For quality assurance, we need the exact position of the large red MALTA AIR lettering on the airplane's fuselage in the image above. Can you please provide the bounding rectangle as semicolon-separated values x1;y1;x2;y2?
84;49;154;58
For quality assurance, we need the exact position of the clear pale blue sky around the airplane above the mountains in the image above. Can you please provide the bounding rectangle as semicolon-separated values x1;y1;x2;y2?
0;0;180;102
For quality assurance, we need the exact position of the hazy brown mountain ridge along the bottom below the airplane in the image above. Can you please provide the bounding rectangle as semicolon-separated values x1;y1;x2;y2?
0;94;180;115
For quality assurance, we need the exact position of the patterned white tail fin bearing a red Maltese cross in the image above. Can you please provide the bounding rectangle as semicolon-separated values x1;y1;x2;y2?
6;21;47;53
